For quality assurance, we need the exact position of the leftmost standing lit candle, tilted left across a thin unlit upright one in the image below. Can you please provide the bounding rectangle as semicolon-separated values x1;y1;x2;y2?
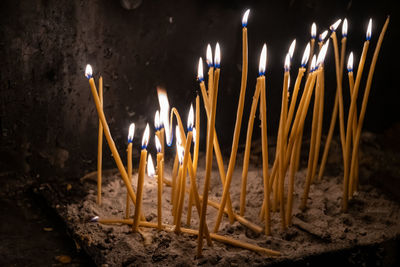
85;65;145;220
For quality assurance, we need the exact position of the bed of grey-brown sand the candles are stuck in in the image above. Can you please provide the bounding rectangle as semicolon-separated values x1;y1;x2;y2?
36;138;400;266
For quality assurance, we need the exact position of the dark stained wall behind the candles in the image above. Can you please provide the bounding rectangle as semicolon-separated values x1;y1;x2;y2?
0;0;400;181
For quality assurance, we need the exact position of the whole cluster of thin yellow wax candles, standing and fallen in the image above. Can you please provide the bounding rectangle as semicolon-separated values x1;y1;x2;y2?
86;10;389;256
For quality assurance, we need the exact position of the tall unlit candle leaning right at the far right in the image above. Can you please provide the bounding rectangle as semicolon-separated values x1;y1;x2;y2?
350;16;390;200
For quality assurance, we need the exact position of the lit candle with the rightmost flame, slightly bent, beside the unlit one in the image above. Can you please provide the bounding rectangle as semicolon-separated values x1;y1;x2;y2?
342;19;372;212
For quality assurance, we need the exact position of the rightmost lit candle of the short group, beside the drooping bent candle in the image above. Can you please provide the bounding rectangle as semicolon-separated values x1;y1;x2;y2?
175;105;194;232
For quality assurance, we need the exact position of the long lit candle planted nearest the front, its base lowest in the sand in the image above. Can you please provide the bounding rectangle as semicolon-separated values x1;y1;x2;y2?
197;43;220;257
